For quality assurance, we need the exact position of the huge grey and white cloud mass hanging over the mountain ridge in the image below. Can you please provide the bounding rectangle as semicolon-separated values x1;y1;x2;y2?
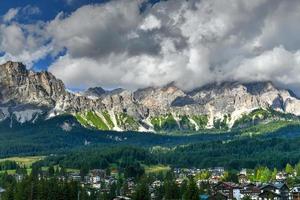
0;0;300;94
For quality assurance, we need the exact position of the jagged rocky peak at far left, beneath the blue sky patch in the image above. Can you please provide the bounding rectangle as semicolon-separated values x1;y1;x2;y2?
0;62;65;106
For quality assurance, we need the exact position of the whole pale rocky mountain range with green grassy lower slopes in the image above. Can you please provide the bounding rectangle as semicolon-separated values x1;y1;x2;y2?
0;62;300;131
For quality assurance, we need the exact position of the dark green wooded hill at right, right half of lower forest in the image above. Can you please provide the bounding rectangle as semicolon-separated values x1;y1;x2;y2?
155;138;300;169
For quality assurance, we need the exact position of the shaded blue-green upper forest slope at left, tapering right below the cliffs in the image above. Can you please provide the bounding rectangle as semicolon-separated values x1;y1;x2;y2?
0;116;234;157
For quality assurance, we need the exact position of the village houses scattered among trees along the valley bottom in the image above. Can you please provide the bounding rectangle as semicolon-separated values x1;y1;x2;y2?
0;167;300;200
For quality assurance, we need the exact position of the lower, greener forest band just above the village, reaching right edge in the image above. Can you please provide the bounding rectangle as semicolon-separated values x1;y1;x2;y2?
35;137;300;173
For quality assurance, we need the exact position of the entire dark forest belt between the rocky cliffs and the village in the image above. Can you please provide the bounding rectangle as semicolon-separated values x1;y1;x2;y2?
0;116;300;169
